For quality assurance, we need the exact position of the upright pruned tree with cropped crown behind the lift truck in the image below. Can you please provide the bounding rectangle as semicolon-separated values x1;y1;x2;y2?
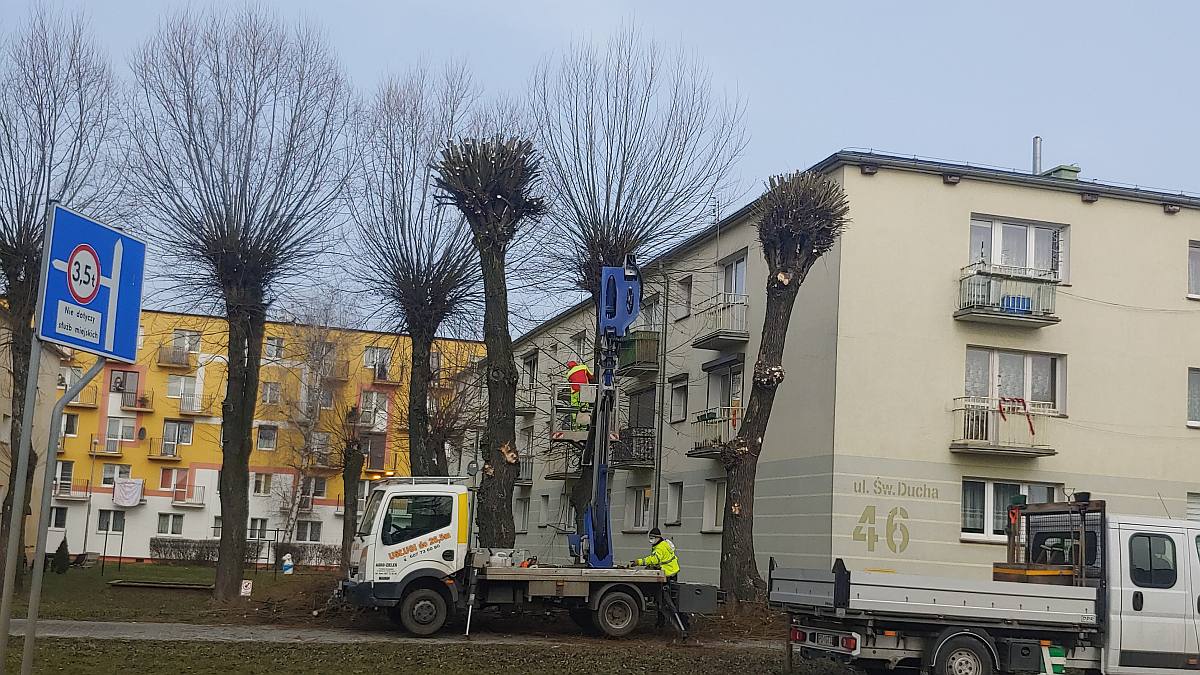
436;135;546;548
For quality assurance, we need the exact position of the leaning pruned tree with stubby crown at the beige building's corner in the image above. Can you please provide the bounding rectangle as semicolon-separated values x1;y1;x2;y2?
721;172;850;601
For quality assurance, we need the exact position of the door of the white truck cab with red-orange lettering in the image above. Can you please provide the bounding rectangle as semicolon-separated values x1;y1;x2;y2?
373;492;467;581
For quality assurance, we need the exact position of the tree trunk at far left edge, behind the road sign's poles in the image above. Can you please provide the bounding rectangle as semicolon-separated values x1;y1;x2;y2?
0;270;37;587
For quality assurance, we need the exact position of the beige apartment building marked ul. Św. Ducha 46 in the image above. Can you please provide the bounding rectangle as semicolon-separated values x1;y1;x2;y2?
514;151;1200;581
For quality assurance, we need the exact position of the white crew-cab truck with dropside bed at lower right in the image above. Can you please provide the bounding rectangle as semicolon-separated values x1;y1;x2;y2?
769;495;1200;675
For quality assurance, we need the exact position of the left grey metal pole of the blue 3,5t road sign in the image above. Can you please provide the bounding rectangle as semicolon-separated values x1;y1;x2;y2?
0;199;58;675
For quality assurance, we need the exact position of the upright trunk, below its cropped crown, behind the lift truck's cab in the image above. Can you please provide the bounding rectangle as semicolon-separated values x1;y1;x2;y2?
475;250;521;548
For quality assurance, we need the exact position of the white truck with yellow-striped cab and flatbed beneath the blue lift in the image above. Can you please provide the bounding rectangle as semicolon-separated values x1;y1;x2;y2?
341;478;716;637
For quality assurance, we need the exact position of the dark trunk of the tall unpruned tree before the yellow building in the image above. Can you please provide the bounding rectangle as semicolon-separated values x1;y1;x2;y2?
212;288;266;602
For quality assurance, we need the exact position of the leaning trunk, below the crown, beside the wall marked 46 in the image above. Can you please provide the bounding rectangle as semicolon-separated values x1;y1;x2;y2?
721;273;803;602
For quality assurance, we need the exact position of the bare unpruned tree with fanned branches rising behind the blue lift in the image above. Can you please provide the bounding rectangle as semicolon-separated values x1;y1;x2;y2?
532;29;745;527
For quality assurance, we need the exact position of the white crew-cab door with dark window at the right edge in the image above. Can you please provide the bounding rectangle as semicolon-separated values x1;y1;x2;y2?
1110;527;1195;674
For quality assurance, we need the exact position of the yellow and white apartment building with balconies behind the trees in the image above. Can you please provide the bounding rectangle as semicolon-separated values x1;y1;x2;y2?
50;311;481;560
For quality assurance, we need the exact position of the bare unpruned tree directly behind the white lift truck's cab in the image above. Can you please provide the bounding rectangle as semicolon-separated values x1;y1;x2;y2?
348;66;479;476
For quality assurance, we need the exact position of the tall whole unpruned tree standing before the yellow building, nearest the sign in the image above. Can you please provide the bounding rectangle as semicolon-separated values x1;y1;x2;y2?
130;10;353;601
